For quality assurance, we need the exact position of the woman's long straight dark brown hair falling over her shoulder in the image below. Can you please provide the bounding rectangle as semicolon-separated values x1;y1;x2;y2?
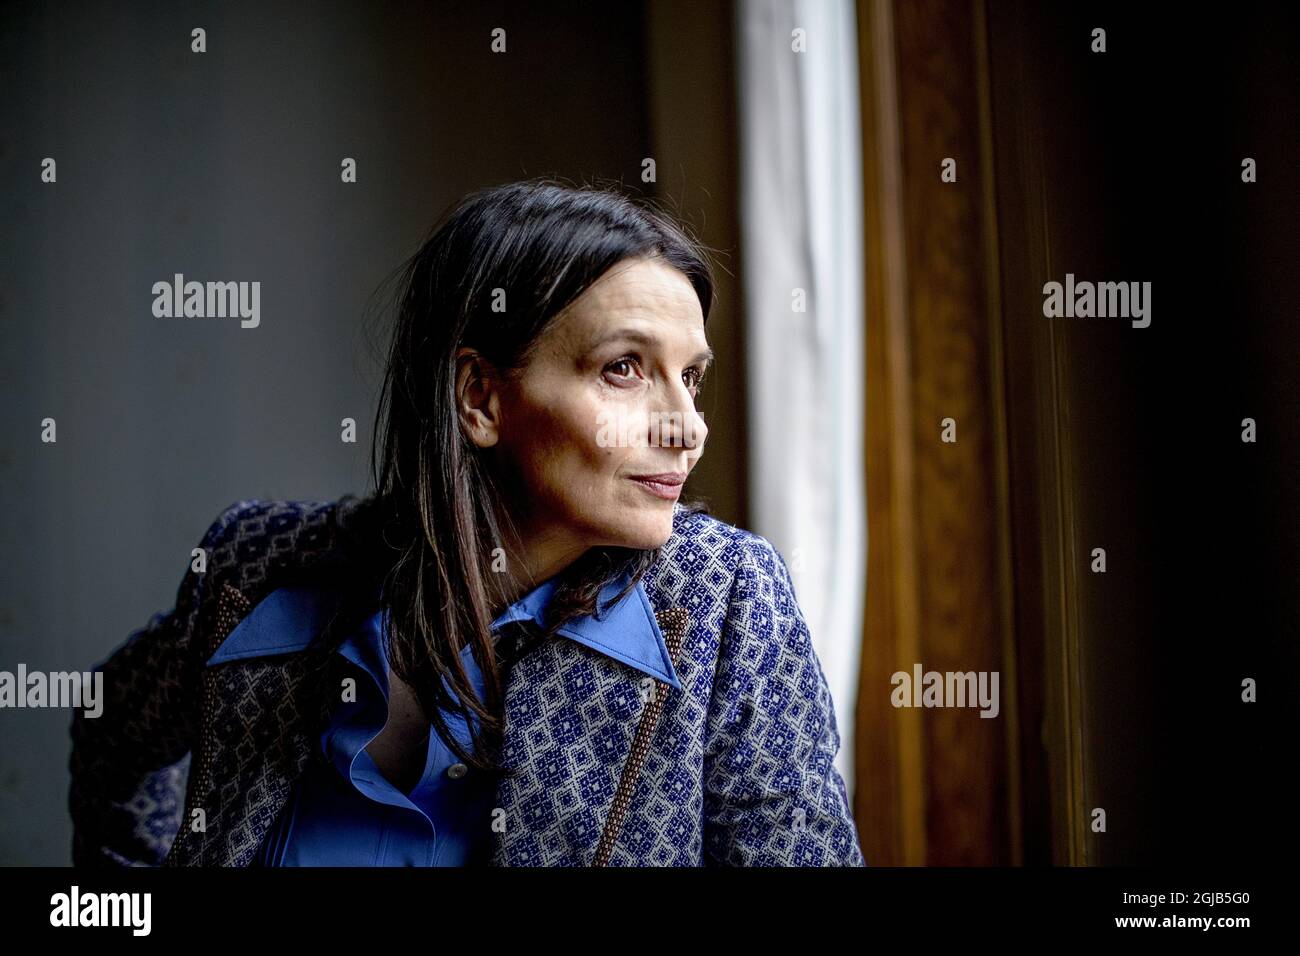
340;178;714;769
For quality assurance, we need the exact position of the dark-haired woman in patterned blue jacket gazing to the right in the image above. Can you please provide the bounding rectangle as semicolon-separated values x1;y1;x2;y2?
70;181;863;866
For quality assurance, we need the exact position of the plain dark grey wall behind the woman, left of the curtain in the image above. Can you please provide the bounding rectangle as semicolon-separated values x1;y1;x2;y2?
0;3;665;864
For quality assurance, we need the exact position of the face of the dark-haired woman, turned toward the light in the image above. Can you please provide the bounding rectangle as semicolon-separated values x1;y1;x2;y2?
462;259;712;580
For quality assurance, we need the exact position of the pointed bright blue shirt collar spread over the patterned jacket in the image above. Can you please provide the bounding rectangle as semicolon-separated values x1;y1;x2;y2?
205;572;681;691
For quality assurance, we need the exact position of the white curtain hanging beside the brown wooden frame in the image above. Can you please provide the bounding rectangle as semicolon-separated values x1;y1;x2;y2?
736;0;866;796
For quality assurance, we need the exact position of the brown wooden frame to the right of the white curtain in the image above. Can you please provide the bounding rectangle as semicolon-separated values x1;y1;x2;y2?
854;0;1087;865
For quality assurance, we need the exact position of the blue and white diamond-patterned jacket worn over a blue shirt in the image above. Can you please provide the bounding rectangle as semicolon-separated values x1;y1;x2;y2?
69;496;865;866
